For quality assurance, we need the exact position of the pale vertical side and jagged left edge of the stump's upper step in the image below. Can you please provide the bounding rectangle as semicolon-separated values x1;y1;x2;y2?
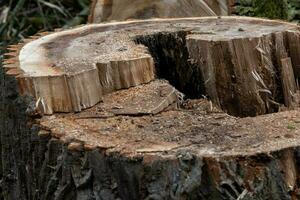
3;29;155;115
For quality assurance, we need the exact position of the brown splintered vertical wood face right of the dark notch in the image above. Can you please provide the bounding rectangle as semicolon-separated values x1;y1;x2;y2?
188;29;299;116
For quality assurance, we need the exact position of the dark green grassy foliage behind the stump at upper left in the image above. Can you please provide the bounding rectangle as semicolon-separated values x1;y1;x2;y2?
0;0;89;52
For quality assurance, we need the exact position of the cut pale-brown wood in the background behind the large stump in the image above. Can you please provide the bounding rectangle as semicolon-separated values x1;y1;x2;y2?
89;0;231;23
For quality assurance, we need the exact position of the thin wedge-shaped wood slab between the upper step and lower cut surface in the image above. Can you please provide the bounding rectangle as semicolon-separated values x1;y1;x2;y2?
80;80;179;118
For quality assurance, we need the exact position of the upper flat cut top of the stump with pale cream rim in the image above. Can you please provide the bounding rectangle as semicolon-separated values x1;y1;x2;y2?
19;17;298;76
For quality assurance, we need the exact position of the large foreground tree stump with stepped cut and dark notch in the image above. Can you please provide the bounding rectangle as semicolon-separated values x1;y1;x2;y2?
0;17;300;200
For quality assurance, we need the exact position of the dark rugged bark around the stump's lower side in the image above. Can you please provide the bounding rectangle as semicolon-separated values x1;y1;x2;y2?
0;63;300;200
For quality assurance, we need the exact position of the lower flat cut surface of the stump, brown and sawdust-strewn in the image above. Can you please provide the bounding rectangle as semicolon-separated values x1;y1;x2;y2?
42;94;300;157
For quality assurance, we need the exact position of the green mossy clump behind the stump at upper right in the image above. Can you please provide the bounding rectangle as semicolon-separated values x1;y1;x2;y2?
253;0;289;20
